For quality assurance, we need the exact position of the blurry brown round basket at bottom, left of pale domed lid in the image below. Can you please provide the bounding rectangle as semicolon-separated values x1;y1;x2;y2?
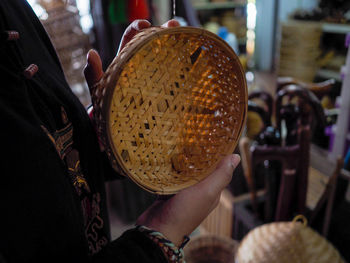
185;235;239;263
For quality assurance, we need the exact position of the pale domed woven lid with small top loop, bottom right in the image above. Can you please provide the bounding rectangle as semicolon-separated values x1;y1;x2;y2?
236;217;344;263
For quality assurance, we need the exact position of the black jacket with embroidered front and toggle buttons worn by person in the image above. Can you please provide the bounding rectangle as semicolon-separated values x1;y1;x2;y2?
0;0;166;262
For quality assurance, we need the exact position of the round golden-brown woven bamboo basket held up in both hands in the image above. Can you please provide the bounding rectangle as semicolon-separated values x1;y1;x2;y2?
92;27;247;194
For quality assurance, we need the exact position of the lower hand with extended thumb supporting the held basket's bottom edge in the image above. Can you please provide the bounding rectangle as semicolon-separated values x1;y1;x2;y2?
136;154;240;246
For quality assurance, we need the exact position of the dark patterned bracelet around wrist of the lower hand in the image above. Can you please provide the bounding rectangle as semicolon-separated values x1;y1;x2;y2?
136;226;190;263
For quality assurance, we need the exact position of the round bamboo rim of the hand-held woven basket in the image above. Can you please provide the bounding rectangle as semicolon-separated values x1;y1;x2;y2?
99;26;248;195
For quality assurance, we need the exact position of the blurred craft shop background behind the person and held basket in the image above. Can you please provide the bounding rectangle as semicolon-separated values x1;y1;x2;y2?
28;0;350;260
